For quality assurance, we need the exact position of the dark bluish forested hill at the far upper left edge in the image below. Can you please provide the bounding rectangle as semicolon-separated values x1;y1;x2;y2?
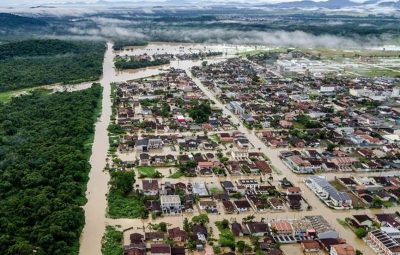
0;13;48;29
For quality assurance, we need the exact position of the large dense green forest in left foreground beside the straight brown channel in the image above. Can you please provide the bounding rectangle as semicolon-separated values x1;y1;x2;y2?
0;85;102;255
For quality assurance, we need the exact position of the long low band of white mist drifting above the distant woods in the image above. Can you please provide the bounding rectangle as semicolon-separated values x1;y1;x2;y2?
69;18;393;48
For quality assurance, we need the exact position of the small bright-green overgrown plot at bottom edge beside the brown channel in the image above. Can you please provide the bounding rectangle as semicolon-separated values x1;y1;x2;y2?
101;226;123;255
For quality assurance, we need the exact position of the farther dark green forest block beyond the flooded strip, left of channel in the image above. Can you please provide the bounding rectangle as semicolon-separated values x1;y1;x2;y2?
0;40;106;91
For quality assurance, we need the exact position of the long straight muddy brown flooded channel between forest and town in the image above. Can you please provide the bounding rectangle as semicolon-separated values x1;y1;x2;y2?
79;44;116;255
